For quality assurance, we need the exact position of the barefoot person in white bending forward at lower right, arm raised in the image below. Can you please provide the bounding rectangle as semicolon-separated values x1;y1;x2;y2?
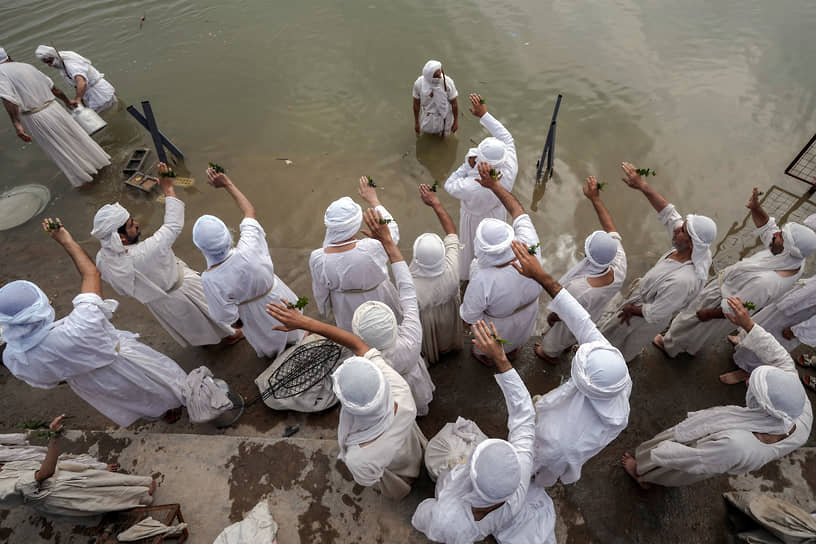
622;297;813;488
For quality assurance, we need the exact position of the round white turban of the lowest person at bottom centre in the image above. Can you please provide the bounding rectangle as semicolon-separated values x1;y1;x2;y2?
465;438;521;508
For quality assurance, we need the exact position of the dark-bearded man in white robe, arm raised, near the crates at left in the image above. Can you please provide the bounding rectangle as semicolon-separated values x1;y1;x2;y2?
91;163;243;347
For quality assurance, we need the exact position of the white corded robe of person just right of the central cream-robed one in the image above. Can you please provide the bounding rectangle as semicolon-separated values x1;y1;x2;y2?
460;214;542;352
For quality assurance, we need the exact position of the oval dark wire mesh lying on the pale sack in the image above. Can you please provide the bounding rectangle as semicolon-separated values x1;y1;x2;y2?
261;340;341;399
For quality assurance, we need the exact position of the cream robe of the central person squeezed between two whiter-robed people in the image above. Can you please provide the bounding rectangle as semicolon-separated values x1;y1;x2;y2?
414;234;464;364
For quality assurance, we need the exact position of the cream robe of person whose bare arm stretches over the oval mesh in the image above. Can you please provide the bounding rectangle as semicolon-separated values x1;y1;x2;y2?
340;349;428;499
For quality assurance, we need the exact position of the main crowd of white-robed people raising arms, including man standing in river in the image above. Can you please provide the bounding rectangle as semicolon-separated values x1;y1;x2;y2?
0;50;816;543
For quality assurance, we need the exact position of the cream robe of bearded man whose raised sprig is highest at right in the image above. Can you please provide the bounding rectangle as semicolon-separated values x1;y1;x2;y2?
598;204;701;362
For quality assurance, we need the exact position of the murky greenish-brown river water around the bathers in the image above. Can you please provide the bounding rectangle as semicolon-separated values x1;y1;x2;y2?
0;0;816;289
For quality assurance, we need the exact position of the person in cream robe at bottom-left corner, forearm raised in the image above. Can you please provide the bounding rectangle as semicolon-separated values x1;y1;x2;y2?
0;415;156;517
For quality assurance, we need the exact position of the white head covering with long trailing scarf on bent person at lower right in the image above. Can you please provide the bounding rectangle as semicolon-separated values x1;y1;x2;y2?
675;365;809;442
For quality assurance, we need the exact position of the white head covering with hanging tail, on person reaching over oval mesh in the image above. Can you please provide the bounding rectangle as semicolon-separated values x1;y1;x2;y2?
332;357;394;459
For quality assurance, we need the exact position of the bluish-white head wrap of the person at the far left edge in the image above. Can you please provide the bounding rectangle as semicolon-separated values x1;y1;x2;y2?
0;280;54;361
